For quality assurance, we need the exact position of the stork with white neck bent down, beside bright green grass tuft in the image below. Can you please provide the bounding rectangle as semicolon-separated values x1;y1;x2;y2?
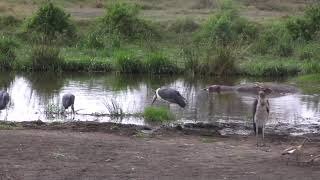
152;88;187;108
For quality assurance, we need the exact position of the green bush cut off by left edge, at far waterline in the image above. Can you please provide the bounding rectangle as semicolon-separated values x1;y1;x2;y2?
0;36;17;69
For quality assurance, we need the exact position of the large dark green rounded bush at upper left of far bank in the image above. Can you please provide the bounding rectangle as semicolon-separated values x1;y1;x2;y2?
26;2;75;39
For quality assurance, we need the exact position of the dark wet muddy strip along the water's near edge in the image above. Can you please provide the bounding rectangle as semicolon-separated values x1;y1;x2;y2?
0;121;320;137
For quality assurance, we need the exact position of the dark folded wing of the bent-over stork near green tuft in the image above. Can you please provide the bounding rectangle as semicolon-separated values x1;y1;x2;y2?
158;88;186;107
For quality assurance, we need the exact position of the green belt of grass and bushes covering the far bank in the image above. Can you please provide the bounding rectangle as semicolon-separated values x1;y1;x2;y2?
0;0;320;76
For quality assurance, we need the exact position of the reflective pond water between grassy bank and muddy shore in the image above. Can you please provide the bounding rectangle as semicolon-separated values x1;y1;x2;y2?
0;73;320;134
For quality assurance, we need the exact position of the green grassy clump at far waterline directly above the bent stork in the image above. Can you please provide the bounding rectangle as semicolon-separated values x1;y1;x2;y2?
145;52;179;74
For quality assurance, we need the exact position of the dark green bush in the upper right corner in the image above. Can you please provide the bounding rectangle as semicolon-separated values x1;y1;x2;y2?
286;4;320;41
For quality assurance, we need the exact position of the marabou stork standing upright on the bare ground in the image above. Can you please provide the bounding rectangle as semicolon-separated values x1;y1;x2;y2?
253;90;269;146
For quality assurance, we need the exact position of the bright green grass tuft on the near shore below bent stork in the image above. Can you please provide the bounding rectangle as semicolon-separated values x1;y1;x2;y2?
143;107;175;123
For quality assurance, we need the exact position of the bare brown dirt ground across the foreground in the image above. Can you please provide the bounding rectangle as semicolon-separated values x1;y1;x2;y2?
0;123;320;180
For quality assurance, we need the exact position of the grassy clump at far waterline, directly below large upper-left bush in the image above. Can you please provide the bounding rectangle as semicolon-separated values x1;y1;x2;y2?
30;45;63;71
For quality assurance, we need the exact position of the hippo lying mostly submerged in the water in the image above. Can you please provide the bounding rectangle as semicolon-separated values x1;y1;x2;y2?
204;83;299;94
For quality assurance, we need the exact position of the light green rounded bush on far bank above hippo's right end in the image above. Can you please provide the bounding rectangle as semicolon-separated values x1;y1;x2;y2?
254;23;294;57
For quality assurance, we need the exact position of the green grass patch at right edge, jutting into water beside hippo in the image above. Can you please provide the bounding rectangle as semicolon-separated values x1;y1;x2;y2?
291;74;320;94
